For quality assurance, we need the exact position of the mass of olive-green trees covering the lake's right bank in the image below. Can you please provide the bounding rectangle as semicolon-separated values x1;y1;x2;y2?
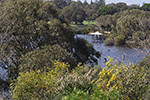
96;3;150;47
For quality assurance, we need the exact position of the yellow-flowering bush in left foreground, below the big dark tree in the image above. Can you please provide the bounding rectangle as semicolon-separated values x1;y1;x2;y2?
10;61;69;100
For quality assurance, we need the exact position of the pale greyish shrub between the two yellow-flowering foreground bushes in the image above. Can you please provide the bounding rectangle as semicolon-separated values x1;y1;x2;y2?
56;64;98;98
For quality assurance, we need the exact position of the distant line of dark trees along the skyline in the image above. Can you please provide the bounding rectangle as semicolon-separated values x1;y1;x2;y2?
51;0;150;24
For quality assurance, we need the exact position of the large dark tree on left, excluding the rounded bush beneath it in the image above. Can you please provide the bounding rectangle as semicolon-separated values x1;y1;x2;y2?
0;0;98;80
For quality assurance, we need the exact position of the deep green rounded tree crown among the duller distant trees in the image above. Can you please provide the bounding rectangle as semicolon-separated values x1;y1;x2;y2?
98;6;117;15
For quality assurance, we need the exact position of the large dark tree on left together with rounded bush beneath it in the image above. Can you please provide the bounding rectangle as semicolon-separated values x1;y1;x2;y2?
0;0;99;86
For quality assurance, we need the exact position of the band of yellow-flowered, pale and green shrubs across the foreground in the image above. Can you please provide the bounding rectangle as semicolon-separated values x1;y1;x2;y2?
10;57;150;100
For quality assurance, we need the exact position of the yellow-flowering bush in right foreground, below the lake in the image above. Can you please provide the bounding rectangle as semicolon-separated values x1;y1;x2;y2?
96;57;150;100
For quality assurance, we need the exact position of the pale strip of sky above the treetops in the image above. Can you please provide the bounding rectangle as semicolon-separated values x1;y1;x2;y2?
75;0;150;6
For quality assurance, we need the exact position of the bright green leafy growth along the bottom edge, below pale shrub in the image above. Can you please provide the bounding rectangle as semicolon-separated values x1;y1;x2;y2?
62;86;121;100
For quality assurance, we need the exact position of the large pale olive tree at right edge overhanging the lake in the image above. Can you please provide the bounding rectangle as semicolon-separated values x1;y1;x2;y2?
116;9;150;51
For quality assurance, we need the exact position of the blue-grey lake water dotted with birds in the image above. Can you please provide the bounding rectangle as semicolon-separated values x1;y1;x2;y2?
77;35;147;67
